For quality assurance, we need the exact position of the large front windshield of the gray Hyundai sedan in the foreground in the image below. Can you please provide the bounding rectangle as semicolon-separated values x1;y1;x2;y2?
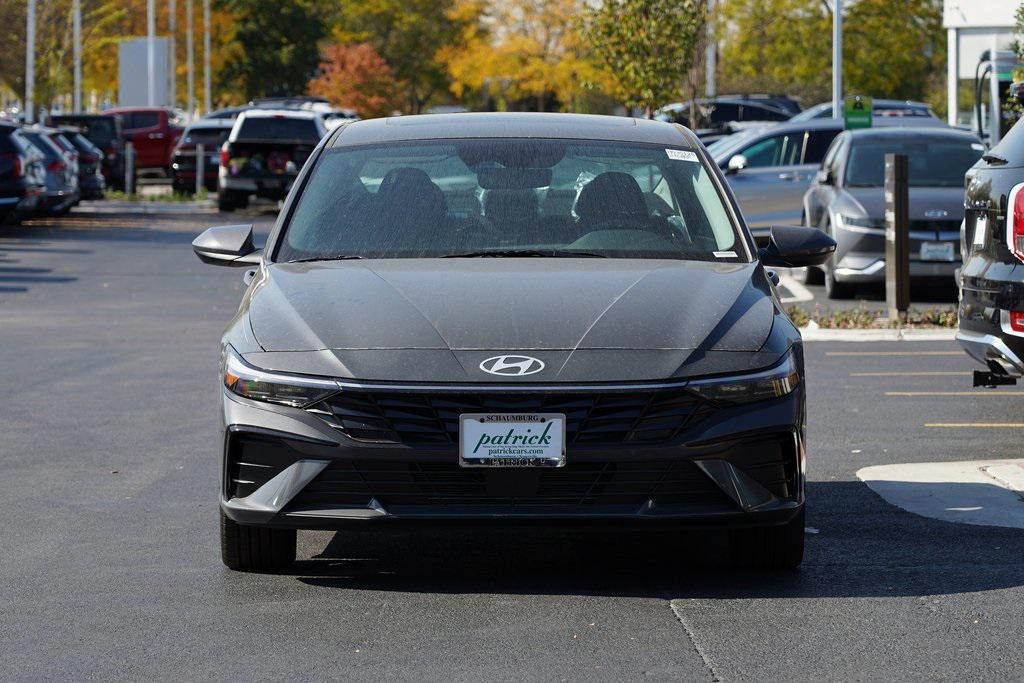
276;138;739;261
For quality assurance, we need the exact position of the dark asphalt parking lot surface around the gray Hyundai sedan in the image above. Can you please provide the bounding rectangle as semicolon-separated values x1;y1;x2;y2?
0;209;1024;681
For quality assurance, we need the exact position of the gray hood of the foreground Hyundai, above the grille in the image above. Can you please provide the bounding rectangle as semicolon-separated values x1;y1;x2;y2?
246;258;778;382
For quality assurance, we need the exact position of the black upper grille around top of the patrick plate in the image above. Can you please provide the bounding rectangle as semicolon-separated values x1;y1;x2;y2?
307;389;710;446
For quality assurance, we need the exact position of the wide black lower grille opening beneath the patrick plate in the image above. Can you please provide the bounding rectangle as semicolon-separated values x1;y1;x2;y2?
290;460;729;510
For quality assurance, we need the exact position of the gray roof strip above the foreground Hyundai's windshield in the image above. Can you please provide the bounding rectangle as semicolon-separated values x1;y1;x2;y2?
332;112;696;146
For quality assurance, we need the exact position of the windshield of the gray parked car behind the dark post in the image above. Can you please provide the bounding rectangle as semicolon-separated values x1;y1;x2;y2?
846;139;984;187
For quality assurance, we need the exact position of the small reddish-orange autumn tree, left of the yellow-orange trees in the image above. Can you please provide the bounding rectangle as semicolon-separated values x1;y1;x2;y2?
309;43;398;118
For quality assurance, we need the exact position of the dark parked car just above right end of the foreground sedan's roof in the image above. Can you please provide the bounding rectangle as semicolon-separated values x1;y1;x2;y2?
654;96;800;144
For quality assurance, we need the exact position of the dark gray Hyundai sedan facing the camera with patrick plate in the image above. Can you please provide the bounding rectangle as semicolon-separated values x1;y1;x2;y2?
193;114;835;570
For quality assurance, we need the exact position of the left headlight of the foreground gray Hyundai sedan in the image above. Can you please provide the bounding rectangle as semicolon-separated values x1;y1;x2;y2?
220;346;338;408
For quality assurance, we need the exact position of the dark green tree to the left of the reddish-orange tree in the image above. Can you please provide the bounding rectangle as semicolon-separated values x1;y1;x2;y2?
217;0;329;99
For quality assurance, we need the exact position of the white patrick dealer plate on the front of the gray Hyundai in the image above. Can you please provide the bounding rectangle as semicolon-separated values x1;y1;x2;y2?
459;413;565;467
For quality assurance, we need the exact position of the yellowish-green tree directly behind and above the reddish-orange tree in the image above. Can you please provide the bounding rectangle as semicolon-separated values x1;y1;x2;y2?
331;0;463;114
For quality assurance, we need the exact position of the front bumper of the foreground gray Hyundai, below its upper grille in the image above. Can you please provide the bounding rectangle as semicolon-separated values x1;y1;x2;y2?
220;386;805;529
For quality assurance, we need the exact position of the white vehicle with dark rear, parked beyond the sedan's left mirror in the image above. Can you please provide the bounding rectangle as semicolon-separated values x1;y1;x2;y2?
217;109;327;211
